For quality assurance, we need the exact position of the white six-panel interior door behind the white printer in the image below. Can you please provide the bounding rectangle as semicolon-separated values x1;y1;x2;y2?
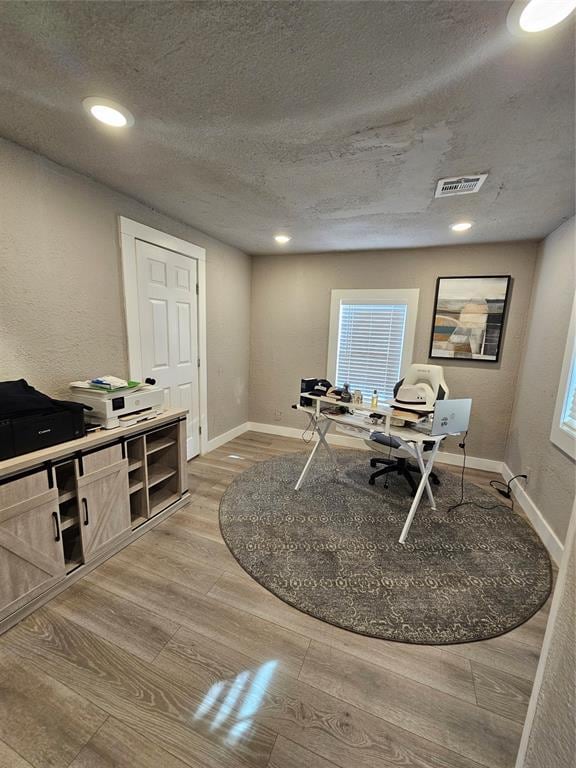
136;240;200;459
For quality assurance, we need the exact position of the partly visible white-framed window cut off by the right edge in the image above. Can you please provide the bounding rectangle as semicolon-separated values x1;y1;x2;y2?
550;299;576;459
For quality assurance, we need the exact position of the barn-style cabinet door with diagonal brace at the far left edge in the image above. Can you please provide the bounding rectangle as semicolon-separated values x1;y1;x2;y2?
0;472;66;616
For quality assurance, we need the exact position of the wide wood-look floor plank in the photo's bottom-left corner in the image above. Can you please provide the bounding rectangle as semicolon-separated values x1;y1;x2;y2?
0;630;106;768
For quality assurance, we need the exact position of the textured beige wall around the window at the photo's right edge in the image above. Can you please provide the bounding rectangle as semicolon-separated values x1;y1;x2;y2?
506;218;576;541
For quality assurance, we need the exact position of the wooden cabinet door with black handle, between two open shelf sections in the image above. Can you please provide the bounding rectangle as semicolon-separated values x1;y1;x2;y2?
77;459;130;562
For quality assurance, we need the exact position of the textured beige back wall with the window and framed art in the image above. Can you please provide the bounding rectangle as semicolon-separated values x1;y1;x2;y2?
250;243;537;460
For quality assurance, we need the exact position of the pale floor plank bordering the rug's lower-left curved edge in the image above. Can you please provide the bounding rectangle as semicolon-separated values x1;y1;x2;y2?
208;572;476;703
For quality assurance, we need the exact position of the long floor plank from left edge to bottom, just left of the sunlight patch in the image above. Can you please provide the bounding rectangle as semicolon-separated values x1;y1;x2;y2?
5;608;275;768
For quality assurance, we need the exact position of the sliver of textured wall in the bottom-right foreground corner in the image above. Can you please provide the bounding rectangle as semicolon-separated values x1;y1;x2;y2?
517;506;576;768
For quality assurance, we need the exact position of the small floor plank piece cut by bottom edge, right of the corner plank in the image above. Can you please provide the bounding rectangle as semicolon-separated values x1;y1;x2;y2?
69;717;188;768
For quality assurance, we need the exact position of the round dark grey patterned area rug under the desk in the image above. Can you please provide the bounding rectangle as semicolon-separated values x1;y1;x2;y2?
220;450;552;645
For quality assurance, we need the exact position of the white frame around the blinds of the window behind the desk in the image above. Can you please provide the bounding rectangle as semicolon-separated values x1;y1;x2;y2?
326;288;420;396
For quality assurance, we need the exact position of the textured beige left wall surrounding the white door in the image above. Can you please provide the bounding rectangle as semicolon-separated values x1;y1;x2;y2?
0;140;251;437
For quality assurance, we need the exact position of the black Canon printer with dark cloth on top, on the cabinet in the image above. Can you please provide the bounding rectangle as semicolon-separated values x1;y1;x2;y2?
0;379;86;459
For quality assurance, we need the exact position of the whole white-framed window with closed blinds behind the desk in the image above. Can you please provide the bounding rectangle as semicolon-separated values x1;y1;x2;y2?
327;289;419;402
